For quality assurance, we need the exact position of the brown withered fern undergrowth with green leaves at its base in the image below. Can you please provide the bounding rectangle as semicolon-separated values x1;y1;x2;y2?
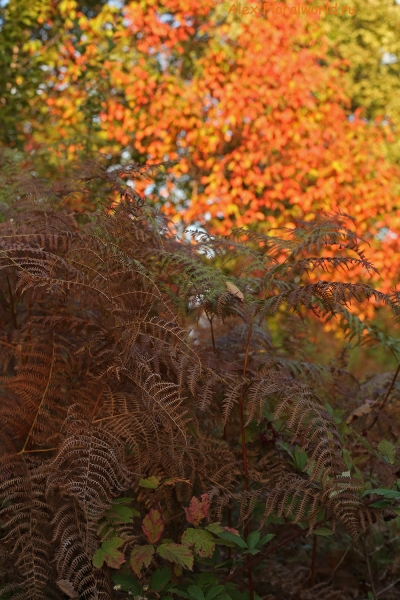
0;163;400;600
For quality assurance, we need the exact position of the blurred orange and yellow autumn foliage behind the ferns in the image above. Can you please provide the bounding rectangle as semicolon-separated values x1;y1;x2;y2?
4;0;400;291
